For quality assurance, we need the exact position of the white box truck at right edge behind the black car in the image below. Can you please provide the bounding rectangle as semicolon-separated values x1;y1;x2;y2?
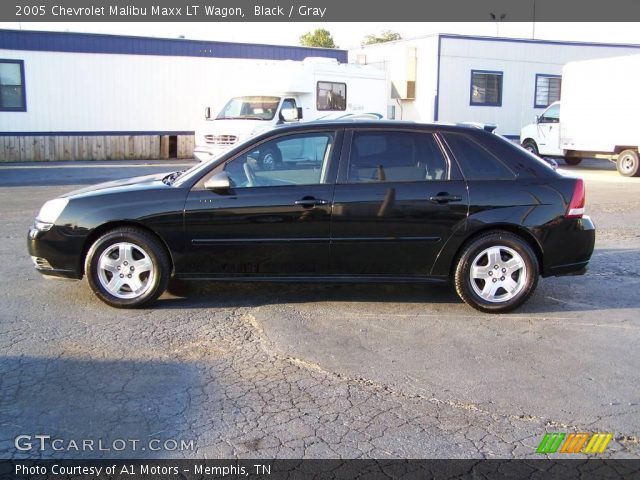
520;55;640;177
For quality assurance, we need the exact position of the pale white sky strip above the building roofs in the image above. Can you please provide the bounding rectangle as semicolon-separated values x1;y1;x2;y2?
0;22;640;49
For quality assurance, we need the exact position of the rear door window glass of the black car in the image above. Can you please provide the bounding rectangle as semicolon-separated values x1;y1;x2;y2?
347;131;447;183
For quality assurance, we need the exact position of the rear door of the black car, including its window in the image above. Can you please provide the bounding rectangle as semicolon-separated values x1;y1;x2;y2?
330;128;469;276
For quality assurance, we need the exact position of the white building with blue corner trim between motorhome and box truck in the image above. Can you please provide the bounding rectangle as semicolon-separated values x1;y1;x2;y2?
349;34;640;139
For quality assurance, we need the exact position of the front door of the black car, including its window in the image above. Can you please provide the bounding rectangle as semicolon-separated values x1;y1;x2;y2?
184;130;339;277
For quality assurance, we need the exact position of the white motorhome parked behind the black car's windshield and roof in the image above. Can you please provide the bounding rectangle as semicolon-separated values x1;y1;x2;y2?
194;57;388;163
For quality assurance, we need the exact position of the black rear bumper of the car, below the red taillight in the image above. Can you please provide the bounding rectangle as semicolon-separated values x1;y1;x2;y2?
542;216;596;277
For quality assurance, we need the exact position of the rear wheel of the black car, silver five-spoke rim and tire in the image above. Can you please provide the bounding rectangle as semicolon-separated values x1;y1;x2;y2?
455;231;539;313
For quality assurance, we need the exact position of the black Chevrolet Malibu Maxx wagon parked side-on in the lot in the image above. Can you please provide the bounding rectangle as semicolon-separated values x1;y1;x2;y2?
28;121;595;312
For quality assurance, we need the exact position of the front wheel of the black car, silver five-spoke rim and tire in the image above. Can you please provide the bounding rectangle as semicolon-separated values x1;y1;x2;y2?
85;227;170;308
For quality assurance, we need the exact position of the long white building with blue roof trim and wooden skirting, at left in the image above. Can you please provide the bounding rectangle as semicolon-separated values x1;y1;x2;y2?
0;30;347;161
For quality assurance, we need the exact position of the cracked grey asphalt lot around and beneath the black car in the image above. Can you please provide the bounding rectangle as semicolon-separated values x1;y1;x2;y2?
0;160;640;458
